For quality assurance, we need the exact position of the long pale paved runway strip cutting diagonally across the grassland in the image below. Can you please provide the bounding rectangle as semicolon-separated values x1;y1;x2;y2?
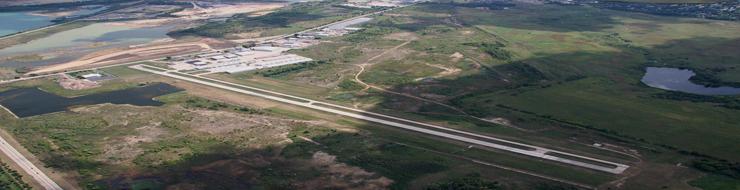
131;65;629;174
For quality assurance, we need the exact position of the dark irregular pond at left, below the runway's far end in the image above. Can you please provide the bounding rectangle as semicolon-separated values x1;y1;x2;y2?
0;83;182;118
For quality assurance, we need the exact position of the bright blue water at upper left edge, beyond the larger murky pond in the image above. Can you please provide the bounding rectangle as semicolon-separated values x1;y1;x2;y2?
0;12;52;36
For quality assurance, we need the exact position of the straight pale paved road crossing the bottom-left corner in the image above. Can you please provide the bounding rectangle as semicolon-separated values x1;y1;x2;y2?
0;137;62;190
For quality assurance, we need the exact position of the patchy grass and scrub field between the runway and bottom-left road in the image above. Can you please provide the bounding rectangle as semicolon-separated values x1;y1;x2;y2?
0;67;600;189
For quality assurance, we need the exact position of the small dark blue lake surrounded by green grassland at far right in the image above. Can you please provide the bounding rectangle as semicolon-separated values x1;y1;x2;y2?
641;67;740;95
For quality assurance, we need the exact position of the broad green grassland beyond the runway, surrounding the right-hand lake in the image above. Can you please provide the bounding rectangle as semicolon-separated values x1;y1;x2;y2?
215;3;740;189
